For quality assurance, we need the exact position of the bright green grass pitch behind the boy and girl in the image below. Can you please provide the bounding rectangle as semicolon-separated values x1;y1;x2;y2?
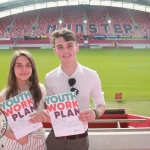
0;49;150;116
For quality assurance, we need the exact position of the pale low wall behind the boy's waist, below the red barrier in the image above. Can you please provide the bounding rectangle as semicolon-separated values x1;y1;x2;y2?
45;128;150;150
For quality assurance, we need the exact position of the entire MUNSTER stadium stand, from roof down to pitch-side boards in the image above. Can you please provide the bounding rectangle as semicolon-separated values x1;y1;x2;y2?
0;6;150;48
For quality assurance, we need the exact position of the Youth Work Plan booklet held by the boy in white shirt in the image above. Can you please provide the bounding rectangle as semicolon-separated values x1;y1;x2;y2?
45;92;84;137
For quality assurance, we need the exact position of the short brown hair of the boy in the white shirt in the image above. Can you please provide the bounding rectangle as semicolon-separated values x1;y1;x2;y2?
50;28;77;48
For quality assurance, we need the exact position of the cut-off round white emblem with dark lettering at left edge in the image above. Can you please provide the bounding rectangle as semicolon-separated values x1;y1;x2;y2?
0;110;8;138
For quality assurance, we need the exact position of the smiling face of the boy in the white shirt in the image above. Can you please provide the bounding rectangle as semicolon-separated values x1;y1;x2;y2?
54;36;79;63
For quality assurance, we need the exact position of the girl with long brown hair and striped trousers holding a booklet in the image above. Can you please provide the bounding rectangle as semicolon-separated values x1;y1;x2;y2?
0;51;46;150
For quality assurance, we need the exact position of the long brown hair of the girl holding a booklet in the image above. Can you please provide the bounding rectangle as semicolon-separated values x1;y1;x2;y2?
6;50;42;108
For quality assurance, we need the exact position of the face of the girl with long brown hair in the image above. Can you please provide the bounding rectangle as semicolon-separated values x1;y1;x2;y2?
14;56;32;81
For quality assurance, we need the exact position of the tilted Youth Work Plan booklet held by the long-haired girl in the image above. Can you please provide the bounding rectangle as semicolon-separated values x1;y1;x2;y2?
0;91;43;139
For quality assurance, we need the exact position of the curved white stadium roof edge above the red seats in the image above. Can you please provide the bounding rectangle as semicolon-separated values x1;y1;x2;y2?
0;0;150;18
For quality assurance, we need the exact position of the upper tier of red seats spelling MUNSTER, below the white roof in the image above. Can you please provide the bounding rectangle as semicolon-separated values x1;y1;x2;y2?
0;6;150;38
